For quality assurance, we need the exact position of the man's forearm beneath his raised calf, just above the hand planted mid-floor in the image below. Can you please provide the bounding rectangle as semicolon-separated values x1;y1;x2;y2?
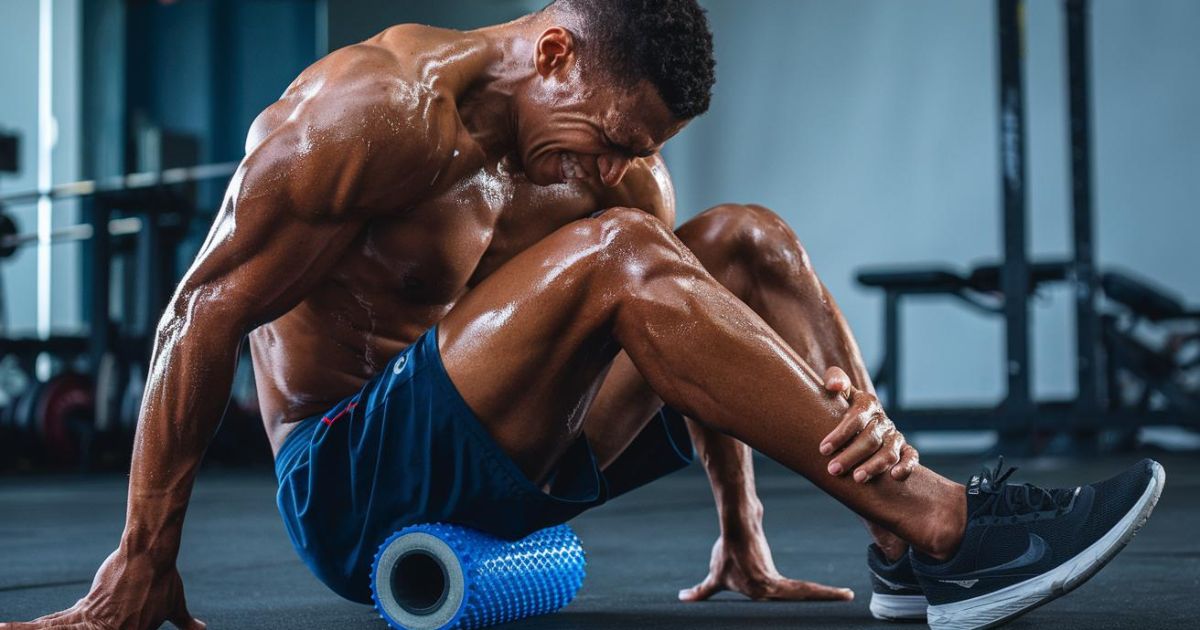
688;419;762;536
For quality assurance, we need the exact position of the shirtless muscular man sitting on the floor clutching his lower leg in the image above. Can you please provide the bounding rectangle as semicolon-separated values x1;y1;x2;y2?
5;0;1163;629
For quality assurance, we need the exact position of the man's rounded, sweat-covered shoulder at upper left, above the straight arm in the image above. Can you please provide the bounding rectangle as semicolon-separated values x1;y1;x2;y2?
239;44;457;214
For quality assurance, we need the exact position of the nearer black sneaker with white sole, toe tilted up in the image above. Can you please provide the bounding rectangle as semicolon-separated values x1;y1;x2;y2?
910;458;1166;630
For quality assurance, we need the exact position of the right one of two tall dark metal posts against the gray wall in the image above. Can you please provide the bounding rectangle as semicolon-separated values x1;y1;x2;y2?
1063;0;1102;421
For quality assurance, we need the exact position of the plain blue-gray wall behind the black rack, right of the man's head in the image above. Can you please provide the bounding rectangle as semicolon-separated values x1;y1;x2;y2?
666;0;1200;403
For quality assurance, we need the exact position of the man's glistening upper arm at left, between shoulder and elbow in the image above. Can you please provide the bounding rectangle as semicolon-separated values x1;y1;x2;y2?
168;127;366;332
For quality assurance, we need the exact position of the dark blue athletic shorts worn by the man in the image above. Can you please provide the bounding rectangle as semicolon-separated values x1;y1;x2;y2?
275;328;692;604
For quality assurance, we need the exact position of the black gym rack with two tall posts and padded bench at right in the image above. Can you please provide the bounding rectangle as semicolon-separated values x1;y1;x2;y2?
858;0;1200;436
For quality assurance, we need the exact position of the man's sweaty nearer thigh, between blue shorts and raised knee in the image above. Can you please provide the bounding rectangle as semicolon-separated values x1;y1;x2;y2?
438;220;619;481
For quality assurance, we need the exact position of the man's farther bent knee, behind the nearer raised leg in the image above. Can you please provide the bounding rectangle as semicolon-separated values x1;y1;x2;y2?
678;204;812;278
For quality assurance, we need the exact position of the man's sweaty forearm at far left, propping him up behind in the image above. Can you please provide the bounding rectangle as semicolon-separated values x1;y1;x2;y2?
121;319;238;563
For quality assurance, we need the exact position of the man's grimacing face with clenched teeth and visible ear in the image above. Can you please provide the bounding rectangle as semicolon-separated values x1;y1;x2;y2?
516;28;686;186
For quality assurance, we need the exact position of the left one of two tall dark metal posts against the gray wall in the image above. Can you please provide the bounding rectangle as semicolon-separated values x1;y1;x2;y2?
996;0;1032;418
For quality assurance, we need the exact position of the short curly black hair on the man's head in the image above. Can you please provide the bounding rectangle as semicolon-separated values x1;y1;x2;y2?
546;0;716;120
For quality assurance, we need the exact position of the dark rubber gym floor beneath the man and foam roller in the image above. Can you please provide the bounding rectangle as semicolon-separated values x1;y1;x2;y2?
0;454;1200;629
